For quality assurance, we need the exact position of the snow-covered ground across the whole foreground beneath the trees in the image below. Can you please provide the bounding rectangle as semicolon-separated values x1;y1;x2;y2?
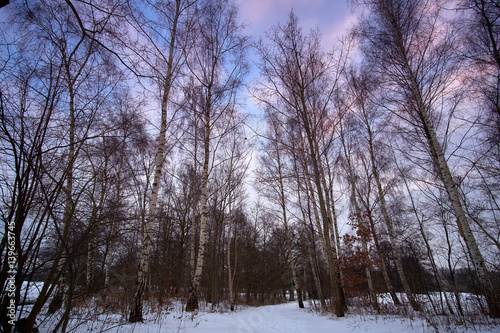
33;302;498;333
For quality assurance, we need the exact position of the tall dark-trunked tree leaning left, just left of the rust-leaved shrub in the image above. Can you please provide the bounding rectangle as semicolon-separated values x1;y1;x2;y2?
254;12;346;317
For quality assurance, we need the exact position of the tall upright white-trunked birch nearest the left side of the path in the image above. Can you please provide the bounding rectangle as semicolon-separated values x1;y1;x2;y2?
186;0;247;311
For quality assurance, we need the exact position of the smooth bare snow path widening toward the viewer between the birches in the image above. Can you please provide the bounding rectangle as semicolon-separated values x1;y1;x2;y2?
119;302;431;333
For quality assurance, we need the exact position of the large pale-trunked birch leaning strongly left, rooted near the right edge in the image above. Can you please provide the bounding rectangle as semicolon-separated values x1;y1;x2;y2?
372;1;500;318
